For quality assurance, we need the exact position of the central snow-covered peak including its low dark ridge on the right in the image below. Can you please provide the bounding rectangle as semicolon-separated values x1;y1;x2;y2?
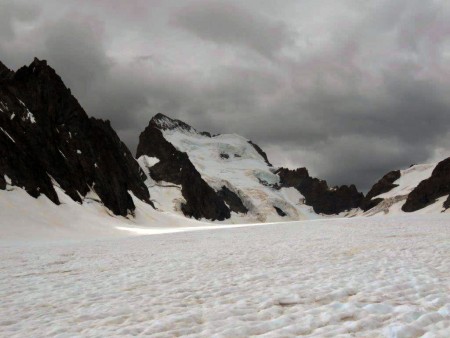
136;114;363;222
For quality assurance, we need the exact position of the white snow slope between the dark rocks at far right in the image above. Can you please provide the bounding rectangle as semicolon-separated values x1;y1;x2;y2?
359;163;447;216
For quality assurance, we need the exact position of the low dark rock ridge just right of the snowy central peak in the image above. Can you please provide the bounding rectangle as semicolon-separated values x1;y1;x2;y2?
275;168;364;215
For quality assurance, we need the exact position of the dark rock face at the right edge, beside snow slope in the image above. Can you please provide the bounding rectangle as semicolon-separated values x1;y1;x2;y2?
402;157;450;212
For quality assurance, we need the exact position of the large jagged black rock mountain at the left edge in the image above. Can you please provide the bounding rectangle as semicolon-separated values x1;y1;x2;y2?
0;59;150;215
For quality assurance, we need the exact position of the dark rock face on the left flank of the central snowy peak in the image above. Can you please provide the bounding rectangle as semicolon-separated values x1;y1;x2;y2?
136;114;230;220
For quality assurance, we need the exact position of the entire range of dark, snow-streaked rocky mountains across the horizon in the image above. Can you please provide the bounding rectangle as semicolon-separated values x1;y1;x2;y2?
0;59;450;223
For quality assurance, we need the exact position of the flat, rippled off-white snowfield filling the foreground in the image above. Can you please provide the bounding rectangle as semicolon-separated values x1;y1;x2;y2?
0;214;450;337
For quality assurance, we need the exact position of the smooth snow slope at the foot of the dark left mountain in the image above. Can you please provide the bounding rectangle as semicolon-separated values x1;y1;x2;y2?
0;181;204;243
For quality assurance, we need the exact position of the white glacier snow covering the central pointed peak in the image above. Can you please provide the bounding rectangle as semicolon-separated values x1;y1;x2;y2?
144;126;320;223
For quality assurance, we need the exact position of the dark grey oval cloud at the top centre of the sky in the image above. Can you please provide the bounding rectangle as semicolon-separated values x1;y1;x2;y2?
172;1;293;57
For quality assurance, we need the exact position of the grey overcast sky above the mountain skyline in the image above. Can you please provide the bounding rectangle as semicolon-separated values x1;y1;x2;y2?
0;0;450;190
